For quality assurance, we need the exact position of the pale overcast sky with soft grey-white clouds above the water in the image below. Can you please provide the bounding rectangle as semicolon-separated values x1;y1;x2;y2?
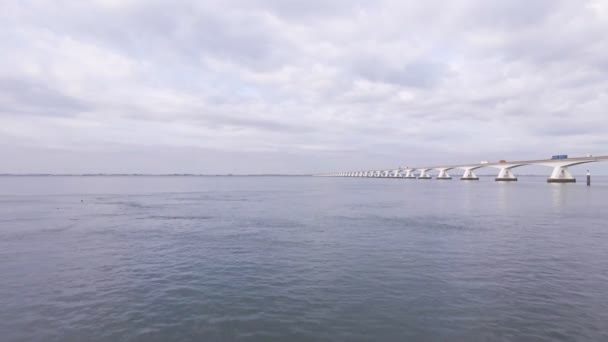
0;0;608;173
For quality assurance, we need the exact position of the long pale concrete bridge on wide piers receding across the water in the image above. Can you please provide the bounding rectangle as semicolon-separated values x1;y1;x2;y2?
315;156;608;183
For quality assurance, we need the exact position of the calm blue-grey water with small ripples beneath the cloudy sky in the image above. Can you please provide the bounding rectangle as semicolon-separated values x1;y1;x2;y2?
0;177;608;341
